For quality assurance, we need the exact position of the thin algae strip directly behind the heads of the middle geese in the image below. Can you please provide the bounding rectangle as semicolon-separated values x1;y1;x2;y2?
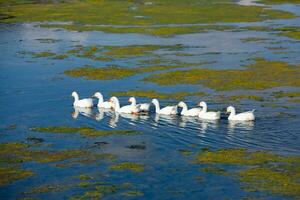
111;90;206;100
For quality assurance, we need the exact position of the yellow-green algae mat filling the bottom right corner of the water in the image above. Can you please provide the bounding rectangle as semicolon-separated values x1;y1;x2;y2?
195;149;300;197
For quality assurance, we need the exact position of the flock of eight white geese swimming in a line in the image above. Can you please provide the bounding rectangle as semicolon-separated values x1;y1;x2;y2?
72;92;255;121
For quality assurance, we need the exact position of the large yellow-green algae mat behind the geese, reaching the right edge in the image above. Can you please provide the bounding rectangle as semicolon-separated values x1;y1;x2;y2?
144;59;300;91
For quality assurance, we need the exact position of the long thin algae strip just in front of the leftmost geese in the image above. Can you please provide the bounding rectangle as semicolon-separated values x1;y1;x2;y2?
30;126;141;137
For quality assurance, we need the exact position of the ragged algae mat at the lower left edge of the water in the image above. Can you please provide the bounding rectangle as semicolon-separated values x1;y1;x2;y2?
0;142;115;185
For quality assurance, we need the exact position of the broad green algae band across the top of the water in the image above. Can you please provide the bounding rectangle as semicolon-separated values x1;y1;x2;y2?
0;0;295;35
